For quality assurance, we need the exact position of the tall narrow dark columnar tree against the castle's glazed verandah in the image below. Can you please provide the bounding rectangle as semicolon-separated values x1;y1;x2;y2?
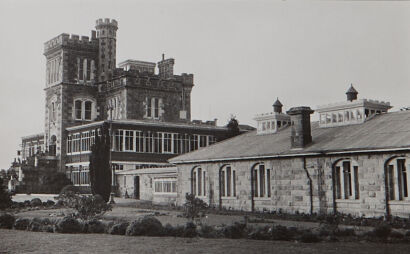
90;123;112;202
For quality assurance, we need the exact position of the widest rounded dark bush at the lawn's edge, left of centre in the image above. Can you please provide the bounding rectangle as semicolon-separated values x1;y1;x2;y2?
126;216;163;236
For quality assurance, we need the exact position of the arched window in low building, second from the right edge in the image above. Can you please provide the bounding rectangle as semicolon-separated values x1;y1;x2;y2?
334;159;359;199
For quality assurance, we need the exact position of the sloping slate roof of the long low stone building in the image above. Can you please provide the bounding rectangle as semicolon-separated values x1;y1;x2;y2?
169;111;410;163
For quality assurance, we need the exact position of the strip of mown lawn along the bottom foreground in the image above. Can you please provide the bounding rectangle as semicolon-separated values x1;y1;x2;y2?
0;229;408;254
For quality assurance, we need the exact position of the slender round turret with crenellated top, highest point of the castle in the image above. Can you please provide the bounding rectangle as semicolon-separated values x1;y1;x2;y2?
95;19;118;81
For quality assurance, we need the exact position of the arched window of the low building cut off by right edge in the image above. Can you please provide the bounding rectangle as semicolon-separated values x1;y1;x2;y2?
387;157;410;200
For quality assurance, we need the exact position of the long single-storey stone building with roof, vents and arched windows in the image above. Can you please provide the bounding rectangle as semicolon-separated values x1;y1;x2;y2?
170;87;410;217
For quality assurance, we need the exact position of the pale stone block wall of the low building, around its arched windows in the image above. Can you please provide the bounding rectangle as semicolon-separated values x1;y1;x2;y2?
177;154;410;217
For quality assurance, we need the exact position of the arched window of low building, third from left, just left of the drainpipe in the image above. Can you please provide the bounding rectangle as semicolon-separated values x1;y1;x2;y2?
252;164;271;198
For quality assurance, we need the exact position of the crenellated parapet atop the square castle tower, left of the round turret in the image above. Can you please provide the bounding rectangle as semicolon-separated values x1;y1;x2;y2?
44;33;98;53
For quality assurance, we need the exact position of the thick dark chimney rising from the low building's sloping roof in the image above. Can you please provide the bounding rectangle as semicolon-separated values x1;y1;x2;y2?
286;107;314;148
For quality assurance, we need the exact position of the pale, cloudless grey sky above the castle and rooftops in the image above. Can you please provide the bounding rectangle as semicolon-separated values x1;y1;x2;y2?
0;0;410;169
